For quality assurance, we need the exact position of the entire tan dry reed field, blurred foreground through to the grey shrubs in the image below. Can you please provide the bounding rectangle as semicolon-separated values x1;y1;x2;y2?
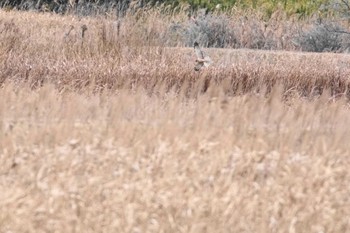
0;8;350;233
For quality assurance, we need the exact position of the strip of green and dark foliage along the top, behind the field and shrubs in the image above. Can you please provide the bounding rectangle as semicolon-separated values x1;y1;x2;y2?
0;0;350;16
